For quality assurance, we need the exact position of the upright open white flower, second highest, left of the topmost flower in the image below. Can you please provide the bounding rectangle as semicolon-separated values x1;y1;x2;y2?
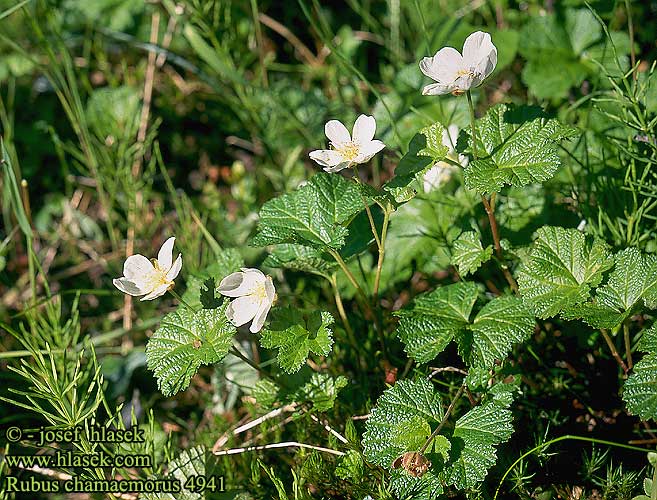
309;115;386;172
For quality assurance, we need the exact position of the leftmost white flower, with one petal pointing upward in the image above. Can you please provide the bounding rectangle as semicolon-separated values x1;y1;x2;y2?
112;236;182;300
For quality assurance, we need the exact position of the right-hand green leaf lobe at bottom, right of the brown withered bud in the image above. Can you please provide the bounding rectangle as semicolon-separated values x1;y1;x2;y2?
443;402;513;489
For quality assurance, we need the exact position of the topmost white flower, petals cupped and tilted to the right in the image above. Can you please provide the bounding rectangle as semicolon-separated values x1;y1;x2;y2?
420;31;497;95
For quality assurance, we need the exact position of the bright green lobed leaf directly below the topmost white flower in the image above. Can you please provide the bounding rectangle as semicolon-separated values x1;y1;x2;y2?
464;104;574;193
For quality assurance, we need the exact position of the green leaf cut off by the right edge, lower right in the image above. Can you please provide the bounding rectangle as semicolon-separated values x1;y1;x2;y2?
623;352;657;420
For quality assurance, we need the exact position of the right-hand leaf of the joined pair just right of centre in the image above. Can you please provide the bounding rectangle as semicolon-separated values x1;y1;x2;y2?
467;296;535;368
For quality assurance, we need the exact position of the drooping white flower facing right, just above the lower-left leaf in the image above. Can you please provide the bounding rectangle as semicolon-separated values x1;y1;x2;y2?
219;267;276;333
